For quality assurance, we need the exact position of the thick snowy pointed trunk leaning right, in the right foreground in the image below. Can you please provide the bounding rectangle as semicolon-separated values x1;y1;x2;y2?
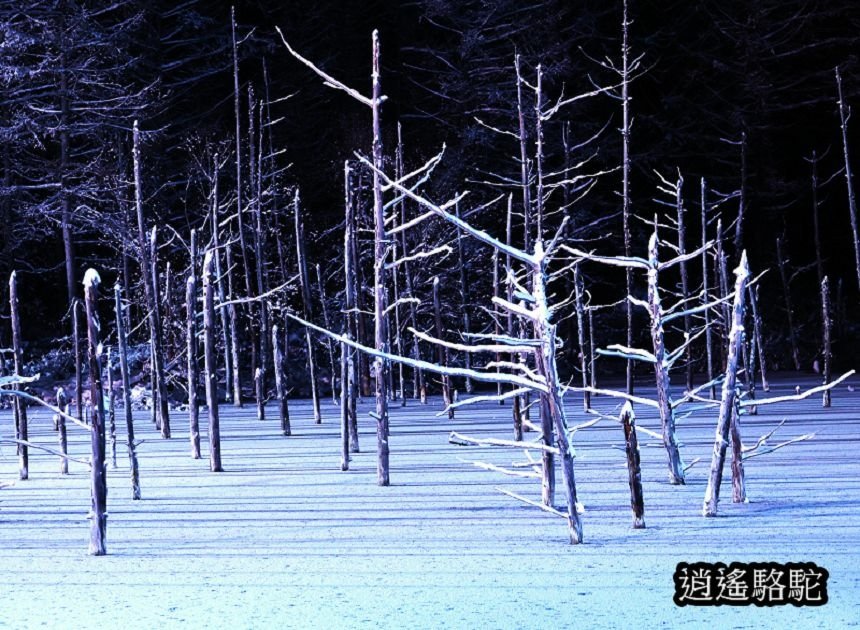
702;252;749;516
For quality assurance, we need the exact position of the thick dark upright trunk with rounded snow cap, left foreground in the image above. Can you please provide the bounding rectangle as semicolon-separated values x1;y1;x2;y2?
84;269;107;556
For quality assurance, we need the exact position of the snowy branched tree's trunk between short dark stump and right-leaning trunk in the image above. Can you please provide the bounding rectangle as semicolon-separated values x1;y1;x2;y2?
648;235;685;485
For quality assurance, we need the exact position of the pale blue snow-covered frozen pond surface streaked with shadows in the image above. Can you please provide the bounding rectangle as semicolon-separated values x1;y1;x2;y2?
0;378;860;630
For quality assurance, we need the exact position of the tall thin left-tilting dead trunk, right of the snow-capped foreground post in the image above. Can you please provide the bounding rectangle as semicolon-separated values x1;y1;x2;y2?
132;120;170;438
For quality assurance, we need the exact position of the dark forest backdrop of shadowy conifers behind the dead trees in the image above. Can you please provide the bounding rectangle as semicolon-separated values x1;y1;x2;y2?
0;0;860;376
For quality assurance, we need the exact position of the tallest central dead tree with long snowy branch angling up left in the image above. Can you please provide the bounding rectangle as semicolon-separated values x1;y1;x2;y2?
278;29;391;486
